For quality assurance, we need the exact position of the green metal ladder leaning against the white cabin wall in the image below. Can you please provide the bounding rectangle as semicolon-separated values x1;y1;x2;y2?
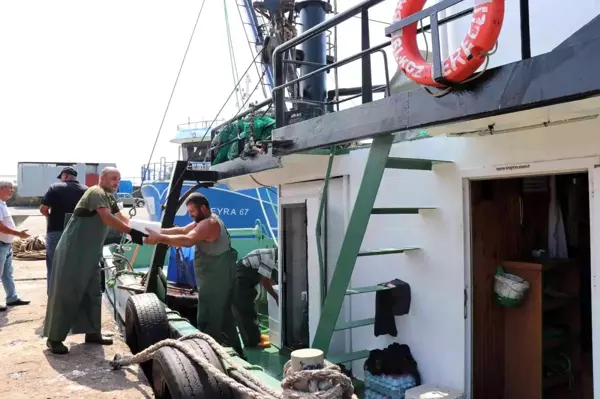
312;134;448;364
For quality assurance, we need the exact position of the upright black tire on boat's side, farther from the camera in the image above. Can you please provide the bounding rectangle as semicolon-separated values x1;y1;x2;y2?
125;293;170;382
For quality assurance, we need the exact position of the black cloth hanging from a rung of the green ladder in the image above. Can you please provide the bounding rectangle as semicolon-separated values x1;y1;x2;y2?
375;279;410;337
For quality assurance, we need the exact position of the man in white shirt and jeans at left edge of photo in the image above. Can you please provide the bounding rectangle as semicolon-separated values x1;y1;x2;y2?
0;180;29;312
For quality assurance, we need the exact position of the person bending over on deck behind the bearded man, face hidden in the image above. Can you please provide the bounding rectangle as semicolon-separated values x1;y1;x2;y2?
233;248;279;348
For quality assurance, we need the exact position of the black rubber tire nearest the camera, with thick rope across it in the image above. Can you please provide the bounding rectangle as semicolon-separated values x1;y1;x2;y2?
152;339;235;399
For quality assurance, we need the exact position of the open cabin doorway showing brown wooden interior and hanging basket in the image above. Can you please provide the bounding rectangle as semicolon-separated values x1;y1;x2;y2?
467;171;593;399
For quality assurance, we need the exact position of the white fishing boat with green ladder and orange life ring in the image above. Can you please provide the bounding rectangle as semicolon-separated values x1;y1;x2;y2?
105;0;600;399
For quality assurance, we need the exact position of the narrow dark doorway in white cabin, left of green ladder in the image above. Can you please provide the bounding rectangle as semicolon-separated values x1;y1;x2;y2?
280;203;309;350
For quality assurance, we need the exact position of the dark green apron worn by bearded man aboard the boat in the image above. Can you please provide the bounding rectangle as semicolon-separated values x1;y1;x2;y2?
194;215;243;356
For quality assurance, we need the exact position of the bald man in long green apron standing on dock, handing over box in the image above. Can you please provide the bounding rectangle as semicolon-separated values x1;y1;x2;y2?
44;168;146;354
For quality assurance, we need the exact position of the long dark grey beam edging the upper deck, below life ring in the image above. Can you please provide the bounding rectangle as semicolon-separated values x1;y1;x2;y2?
273;28;600;156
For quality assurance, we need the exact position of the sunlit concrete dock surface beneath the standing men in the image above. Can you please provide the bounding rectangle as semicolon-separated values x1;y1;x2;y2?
0;210;154;399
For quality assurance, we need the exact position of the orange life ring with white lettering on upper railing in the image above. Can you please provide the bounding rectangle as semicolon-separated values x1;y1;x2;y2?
392;0;505;87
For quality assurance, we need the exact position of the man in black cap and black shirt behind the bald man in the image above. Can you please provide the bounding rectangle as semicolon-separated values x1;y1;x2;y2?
40;166;87;293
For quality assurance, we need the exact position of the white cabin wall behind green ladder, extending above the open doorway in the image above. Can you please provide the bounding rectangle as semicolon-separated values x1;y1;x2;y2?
347;121;600;390
